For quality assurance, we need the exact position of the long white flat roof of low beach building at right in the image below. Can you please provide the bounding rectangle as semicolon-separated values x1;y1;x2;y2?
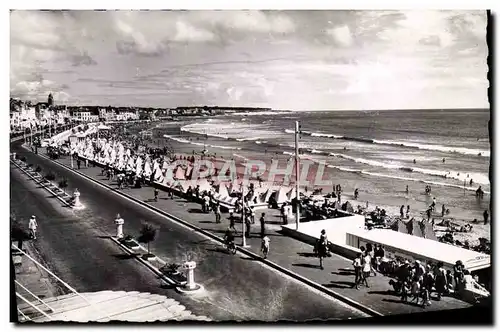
346;228;491;272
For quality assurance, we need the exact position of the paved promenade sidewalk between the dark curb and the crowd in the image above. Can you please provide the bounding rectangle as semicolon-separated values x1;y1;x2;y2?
45;150;470;315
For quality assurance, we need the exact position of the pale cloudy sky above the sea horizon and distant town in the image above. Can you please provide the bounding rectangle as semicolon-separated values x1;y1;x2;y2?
10;10;489;110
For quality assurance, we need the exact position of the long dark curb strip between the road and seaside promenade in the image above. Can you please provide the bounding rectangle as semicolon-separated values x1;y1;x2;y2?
23;146;384;317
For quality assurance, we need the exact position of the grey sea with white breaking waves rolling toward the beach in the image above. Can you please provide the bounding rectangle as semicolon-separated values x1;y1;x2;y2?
157;109;490;233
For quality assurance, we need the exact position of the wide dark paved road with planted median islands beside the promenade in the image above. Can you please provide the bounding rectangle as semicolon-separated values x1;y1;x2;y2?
11;145;361;320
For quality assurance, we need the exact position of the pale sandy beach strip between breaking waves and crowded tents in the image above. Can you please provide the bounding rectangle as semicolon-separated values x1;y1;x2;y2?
140;118;490;244
